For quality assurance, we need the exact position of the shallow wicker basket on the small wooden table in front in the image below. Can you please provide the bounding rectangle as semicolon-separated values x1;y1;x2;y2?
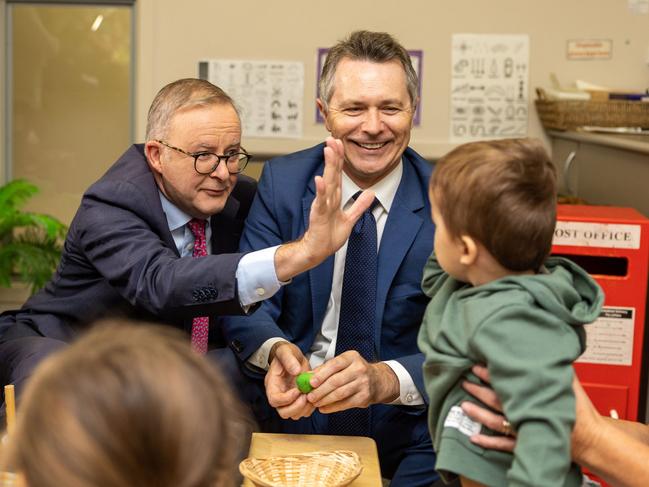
239;450;363;487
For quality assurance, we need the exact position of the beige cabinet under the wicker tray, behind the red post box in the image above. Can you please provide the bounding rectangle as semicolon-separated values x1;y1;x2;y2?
550;131;649;216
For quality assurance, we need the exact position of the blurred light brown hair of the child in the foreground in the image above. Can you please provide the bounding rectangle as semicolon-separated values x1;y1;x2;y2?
5;321;251;487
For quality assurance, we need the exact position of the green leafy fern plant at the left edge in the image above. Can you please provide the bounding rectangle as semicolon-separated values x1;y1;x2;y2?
0;179;67;294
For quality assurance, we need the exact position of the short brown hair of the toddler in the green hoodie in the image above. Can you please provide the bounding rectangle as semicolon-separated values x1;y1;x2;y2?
430;139;556;272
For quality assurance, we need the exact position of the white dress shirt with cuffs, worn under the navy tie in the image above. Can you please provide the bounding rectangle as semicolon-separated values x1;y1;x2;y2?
248;164;424;406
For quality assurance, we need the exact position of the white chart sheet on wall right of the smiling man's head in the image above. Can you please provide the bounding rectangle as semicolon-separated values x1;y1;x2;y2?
450;34;529;142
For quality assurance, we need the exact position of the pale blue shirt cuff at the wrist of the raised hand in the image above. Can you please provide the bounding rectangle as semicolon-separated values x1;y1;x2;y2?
236;245;284;306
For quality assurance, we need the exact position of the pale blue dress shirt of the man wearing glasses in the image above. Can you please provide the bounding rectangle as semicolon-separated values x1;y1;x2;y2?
158;191;284;309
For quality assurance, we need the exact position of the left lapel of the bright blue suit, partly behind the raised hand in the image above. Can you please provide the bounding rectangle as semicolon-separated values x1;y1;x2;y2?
302;166;334;334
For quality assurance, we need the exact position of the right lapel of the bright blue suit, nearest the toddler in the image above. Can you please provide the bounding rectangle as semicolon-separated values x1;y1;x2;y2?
375;155;425;347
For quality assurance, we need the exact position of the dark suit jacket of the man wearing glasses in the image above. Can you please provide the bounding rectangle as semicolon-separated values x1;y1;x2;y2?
0;145;256;341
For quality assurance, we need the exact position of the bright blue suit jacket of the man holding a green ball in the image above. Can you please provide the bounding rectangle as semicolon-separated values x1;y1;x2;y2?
223;144;434;398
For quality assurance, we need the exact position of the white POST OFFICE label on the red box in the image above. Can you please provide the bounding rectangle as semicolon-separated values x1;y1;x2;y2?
552;221;641;249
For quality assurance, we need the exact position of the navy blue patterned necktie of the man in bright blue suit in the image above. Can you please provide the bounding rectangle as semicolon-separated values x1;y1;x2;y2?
328;191;378;436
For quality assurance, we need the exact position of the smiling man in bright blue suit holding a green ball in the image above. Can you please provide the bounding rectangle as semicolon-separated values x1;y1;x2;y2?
224;31;437;487
